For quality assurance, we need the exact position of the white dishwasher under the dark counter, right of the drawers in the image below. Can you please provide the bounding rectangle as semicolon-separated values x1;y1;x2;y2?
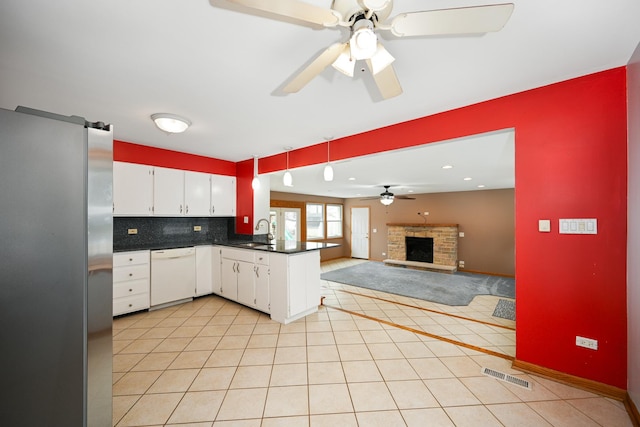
151;247;196;310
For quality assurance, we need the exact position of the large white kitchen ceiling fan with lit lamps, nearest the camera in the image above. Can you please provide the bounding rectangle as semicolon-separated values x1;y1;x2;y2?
218;0;513;99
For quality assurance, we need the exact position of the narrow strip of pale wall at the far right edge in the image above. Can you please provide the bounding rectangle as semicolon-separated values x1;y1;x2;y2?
627;41;640;408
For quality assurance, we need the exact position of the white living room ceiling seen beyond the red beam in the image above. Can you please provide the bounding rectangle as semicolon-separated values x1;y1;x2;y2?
271;130;515;198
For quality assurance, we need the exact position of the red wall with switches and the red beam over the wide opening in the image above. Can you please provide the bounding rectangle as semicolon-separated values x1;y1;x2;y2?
258;68;627;389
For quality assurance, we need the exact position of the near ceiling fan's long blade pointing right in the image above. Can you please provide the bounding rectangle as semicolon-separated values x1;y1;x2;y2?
390;3;513;37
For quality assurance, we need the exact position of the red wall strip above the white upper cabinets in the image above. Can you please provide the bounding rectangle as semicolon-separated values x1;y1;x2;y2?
113;140;236;176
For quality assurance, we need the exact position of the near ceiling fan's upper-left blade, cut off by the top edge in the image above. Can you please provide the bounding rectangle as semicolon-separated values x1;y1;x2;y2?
229;0;342;27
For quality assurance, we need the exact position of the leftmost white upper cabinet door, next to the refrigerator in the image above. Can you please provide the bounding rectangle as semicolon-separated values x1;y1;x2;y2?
113;162;153;216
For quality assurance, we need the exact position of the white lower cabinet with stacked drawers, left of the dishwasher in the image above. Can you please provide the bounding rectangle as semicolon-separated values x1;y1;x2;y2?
113;251;150;316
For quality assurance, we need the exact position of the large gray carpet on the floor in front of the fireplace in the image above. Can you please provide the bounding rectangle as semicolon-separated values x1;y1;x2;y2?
320;262;515;306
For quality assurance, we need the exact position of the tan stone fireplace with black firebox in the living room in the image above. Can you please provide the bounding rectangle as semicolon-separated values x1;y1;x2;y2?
384;223;458;272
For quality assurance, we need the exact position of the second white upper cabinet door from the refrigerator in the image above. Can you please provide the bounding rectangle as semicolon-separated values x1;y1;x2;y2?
153;167;185;216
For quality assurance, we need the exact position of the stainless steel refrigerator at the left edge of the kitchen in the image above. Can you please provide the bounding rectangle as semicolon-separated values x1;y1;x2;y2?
0;107;113;427
